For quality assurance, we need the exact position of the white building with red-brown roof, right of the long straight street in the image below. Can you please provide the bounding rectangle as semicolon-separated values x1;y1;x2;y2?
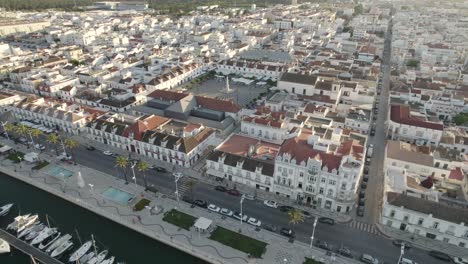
388;105;444;145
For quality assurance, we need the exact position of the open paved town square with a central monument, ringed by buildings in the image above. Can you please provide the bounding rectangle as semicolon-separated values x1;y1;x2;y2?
175;77;268;107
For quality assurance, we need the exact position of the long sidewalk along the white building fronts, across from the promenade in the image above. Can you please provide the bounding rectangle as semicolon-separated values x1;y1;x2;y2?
73;136;353;223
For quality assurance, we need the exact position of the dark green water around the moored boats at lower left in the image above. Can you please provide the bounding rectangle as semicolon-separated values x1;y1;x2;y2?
0;173;206;264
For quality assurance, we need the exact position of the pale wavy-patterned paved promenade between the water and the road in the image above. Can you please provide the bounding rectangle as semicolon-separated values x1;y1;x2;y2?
0;140;358;264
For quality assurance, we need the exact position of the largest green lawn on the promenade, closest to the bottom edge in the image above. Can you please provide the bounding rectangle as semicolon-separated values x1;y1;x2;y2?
210;226;267;258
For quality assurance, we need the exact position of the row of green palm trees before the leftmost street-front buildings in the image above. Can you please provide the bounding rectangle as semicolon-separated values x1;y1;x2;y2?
4;123;78;158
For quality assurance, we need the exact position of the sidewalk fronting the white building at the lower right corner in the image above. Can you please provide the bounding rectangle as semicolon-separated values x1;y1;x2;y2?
376;223;468;258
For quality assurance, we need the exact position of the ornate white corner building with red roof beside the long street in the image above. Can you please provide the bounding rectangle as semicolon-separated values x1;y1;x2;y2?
273;128;364;213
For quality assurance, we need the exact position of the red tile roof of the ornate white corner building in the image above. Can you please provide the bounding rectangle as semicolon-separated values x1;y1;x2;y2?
279;129;342;172
